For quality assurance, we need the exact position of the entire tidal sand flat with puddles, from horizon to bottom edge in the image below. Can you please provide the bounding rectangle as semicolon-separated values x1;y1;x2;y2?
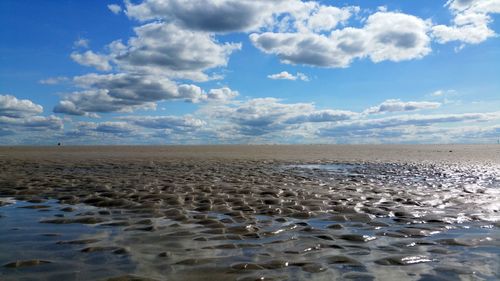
0;145;500;280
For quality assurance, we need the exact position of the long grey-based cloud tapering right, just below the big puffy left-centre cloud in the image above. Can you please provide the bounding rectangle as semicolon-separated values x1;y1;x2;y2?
54;73;238;117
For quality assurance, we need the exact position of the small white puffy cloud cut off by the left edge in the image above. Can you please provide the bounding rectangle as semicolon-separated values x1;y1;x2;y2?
0;95;43;118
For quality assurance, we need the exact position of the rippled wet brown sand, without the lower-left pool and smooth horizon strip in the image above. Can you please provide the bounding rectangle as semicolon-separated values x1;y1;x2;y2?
0;156;500;280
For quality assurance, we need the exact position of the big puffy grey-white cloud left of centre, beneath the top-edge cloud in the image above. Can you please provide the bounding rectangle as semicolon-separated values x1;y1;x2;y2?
111;22;241;81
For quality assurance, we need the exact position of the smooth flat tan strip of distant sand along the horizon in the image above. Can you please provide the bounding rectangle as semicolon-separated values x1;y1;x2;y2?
0;144;500;164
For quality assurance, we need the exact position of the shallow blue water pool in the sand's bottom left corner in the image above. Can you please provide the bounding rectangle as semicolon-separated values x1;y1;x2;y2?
0;200;135;280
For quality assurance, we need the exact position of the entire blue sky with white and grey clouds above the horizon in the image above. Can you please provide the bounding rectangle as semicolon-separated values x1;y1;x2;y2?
0;0;500;145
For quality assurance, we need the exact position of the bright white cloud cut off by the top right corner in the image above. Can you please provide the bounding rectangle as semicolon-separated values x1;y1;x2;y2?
432;0;500;44
